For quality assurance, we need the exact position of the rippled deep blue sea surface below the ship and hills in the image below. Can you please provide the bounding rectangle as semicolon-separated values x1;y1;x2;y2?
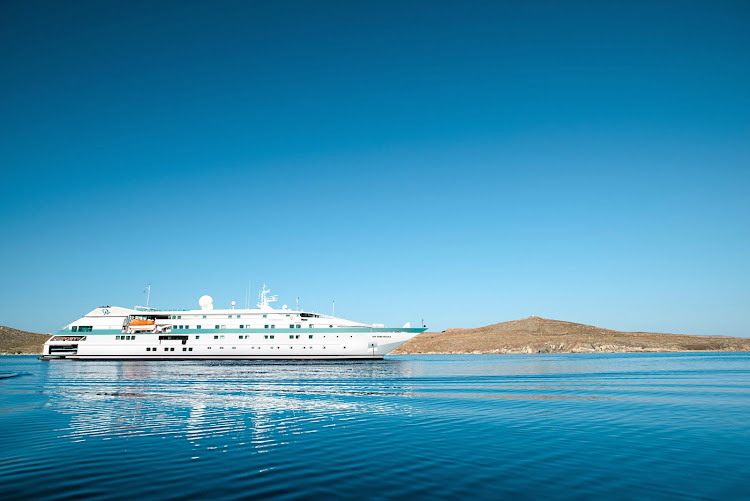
0;353;750;500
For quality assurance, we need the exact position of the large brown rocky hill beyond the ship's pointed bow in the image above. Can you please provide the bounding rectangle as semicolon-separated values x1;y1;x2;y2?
392;316;750;355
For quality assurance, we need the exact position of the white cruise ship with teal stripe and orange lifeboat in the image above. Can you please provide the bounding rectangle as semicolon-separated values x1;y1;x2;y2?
40;285;425;360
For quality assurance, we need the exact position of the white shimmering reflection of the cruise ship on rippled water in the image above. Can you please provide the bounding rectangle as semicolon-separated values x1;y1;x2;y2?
48;361;420;450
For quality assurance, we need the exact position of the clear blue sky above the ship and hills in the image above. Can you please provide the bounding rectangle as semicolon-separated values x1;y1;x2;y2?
0;0;750;335
